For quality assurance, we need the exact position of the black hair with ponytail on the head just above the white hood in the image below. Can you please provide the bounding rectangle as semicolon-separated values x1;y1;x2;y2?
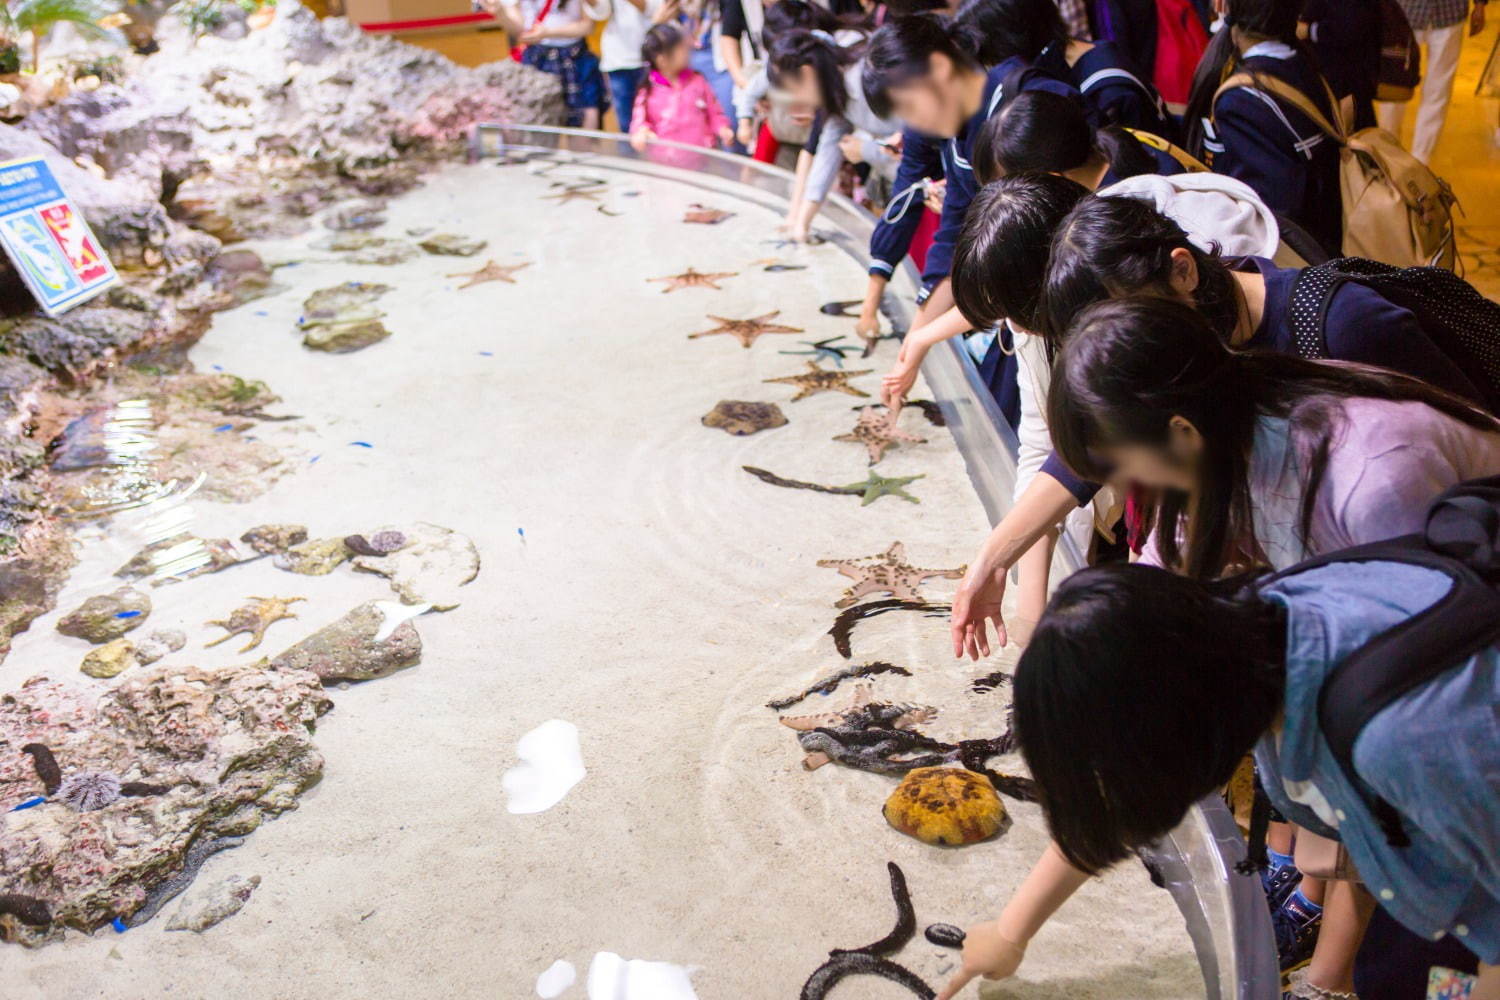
974;90;1157;184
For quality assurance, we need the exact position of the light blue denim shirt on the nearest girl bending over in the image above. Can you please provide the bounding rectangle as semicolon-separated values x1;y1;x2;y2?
1256;562;1500;964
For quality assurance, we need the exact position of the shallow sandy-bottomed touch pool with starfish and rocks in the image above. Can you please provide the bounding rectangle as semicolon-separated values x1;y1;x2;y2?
0;137;1203;1000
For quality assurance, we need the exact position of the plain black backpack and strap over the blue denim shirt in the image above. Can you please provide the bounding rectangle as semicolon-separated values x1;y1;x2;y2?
1256;477;1500;847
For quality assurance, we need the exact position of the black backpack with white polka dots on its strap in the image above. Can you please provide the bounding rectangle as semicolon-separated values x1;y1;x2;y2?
1289;256;1500;414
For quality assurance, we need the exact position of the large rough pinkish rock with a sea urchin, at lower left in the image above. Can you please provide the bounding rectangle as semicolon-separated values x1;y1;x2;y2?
0;664;332;946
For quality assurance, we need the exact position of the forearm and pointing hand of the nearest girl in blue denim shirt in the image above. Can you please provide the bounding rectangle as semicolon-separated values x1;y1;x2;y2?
938;844;1089;1000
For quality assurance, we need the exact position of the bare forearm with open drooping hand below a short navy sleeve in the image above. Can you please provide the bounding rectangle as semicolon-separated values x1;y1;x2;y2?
951;472;1079;660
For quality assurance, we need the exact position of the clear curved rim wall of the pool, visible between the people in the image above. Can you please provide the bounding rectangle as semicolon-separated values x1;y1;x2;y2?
470;124;1281;1000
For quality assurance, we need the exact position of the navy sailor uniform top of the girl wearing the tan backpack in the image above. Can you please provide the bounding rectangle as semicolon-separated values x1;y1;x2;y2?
1203;42;1344;256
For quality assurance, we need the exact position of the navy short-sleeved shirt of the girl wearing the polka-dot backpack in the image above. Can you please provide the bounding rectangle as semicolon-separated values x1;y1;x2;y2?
1041;256;1485;507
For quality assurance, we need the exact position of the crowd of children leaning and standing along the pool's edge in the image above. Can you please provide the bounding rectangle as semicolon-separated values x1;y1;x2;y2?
486;0;1500;1000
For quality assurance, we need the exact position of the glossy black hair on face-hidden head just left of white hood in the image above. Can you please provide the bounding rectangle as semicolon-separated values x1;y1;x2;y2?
953;174;1089;330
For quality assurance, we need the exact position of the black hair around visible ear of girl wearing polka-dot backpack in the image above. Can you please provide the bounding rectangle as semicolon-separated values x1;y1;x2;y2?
1038;193;1242;355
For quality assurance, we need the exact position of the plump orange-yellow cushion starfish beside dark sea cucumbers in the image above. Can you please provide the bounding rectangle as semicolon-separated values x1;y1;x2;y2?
882;768;1007;847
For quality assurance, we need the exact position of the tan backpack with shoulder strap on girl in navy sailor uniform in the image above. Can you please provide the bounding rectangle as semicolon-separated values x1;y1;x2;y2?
1214;73;1458;271
